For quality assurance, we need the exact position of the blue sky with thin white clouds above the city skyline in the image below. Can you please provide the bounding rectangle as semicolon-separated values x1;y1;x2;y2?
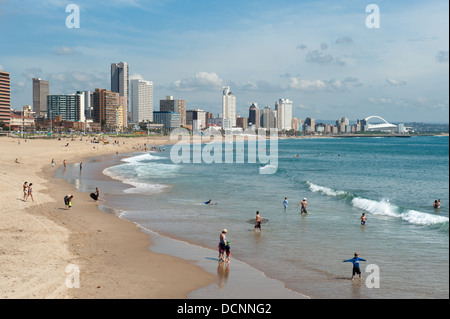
0;0;449;123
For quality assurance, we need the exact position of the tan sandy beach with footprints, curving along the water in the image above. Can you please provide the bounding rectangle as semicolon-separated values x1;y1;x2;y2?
0;137;216;299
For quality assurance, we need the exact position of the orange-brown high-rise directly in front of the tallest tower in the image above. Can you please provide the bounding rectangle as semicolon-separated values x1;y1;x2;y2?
92;89;119;130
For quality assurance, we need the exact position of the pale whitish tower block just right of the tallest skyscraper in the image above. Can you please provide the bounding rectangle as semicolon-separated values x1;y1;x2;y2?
130;80;153;123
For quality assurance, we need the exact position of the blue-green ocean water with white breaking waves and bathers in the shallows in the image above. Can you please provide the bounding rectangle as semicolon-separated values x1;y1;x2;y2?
62;137;450;298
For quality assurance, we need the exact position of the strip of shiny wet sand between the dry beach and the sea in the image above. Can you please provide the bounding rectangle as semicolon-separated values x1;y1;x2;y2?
59;151;310;299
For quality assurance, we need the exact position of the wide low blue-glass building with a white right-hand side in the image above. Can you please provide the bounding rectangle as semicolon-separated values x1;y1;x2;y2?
46;92;85;122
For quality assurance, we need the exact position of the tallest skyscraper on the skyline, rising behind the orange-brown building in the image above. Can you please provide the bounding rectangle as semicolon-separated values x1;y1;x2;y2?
111;62;131;127
